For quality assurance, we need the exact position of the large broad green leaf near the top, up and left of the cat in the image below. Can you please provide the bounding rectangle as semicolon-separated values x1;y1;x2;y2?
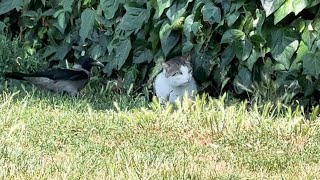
117;6;150;33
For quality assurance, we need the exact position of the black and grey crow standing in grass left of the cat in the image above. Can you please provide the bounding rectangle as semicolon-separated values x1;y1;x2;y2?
5;56;103;95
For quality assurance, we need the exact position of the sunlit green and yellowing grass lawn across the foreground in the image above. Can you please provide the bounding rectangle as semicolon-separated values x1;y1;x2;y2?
0;88;320;179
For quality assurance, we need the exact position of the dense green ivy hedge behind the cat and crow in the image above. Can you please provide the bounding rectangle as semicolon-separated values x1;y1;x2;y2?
0;0;320;103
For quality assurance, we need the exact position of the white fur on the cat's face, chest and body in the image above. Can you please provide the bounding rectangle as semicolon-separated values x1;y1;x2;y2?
154;66;197;104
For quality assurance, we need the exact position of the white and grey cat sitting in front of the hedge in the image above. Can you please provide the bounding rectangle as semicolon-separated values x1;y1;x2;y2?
154;55;198;104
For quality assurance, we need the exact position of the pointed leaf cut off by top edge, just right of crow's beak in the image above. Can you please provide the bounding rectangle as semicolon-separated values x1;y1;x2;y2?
99;0;123;19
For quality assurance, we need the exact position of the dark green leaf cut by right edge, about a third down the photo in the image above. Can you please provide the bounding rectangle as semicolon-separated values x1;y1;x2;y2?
302;52;320;78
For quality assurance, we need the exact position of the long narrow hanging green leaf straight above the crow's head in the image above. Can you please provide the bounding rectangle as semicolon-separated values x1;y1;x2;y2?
79;8;95;42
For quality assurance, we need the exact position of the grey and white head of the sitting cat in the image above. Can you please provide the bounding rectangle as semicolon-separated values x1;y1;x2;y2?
162;55;192;86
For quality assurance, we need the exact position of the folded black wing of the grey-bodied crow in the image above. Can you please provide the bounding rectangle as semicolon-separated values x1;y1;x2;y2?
28;68;89;81
